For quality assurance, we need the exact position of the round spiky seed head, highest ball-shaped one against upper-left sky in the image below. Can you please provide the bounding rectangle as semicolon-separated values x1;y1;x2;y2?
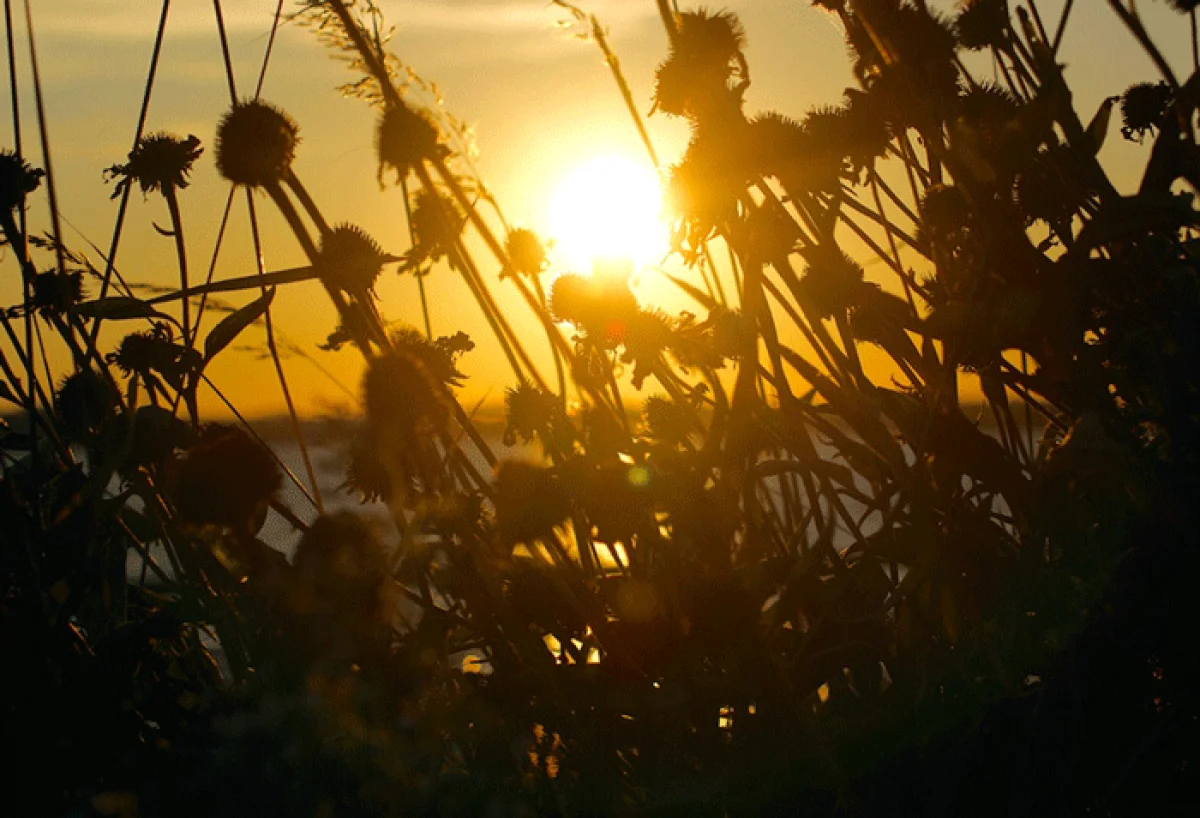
217;100;300;187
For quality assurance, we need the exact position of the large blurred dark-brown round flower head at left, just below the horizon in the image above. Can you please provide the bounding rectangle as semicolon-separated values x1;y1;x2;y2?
174;423;282;535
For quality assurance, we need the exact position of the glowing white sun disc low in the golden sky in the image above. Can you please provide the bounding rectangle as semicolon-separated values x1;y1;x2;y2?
550;156;667;272
